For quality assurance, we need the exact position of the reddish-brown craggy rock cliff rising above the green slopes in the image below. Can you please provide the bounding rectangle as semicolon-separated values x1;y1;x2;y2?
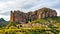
10;8;57;23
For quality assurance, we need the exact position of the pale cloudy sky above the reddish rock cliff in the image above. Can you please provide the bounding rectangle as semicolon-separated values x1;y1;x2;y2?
0;0;60;20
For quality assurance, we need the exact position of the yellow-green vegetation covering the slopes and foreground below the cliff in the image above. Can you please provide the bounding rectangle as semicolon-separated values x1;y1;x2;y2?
0;16;60;34
